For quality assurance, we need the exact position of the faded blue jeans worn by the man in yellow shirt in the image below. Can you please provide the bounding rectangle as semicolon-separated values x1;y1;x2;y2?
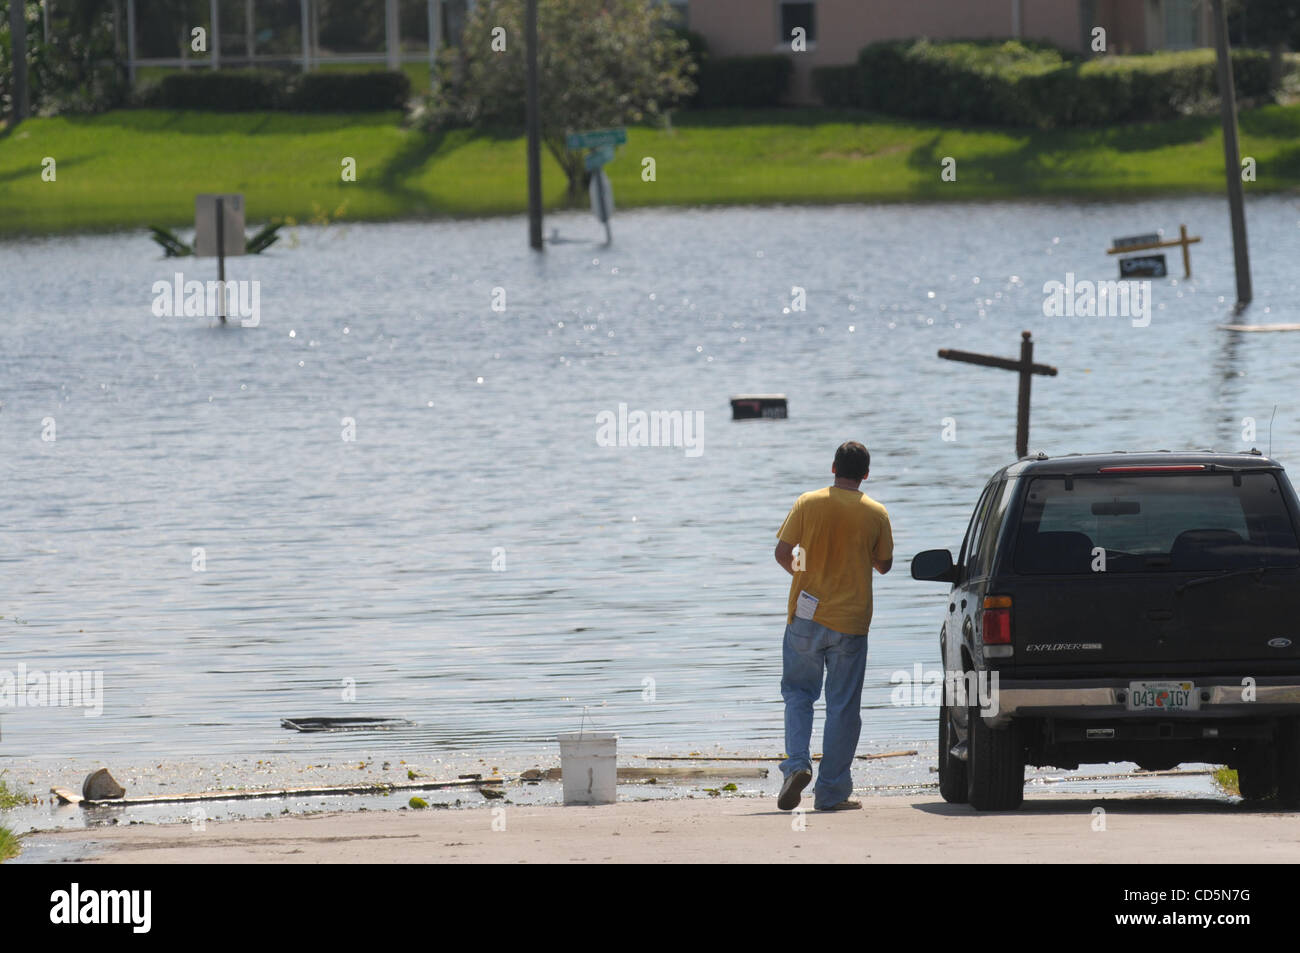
781;619;867;809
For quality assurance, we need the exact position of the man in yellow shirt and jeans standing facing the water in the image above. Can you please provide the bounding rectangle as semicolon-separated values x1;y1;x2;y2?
776;441;893;811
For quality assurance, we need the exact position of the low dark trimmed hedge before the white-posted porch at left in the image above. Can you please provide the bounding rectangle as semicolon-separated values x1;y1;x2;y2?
140;69;411;112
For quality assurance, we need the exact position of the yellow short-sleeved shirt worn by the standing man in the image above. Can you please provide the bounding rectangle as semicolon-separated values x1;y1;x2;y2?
776;486;893;636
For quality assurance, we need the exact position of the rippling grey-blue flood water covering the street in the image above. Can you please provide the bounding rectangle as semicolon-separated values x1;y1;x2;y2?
0;198;1300;766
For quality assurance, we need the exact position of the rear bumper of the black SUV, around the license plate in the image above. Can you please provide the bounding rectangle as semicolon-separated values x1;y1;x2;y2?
985;676;1300;725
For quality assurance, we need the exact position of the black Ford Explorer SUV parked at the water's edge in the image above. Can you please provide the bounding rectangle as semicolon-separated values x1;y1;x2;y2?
911;451;1300;810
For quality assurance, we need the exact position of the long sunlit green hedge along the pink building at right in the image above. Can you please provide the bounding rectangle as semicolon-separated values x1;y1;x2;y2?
813;39;1270;129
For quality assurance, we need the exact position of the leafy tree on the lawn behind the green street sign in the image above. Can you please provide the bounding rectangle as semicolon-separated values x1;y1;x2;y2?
438;0;694;198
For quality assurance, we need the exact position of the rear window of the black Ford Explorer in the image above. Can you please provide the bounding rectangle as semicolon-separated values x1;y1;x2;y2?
1015;472;1300;573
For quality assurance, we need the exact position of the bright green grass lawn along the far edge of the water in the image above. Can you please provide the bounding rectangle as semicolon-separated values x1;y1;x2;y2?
0;105;1300;234
